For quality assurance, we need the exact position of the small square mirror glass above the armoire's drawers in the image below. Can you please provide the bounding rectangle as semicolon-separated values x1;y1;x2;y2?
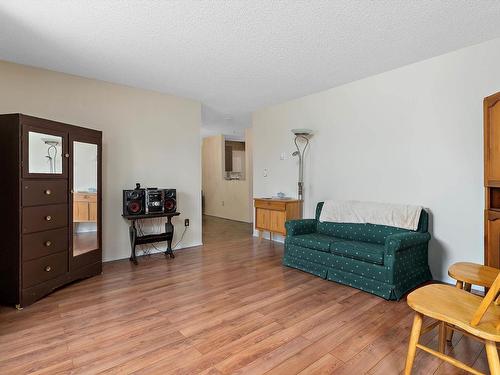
28;132;62;174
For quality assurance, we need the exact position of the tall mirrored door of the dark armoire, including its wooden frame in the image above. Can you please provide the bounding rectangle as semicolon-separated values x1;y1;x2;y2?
69;131;102;270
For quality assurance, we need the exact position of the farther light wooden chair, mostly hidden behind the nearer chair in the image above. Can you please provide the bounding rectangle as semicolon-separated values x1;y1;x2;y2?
446;262;500;342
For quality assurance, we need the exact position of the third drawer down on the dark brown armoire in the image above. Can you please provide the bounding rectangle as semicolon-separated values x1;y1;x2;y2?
22;228;68;262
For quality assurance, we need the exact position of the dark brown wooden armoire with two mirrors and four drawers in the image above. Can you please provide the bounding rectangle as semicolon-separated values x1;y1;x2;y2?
0;114;102;308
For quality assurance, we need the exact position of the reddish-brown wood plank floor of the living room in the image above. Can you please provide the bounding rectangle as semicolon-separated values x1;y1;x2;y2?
0;217;487;375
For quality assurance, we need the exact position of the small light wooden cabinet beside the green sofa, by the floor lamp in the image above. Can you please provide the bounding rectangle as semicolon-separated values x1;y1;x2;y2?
254;198;302;237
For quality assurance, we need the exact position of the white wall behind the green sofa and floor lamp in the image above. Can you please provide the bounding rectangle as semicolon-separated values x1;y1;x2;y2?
253;39;500;280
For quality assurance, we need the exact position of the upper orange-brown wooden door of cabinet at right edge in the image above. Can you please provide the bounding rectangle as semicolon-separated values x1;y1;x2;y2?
484;95;500;186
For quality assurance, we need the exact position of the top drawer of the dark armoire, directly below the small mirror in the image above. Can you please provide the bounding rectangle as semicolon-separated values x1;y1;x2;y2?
22;180;68;207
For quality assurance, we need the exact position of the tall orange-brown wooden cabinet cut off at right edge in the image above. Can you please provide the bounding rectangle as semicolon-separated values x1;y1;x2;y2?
483;93;500;268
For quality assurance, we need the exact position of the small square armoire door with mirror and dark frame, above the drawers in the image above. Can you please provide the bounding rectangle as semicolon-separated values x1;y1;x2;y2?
22;120;69;179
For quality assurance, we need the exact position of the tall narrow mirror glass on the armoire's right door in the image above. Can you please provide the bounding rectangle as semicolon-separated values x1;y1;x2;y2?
73;142;99;256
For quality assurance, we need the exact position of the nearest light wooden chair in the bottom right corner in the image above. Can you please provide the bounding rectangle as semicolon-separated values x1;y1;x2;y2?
405;274;500;375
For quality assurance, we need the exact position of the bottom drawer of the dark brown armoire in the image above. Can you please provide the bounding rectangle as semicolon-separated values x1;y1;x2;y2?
23;251;68;288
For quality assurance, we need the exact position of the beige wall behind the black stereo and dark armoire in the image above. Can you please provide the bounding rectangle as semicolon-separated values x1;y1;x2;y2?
0;61;201;260
